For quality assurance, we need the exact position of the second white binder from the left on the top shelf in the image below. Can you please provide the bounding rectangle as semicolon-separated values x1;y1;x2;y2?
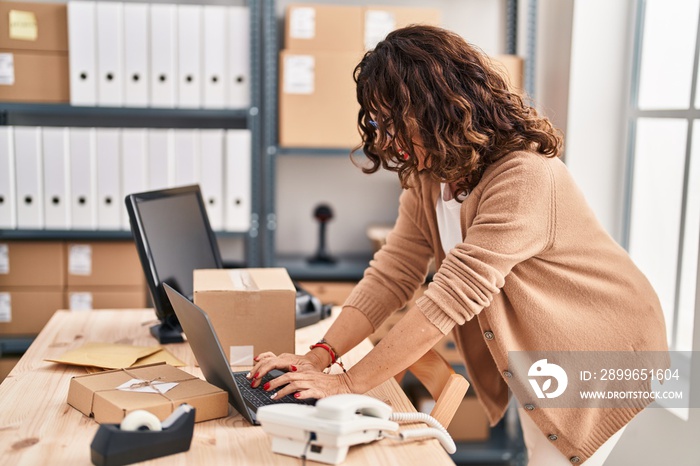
95;1;124;107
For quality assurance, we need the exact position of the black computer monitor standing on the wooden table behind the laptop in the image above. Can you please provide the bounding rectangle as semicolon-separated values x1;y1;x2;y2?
125;185;223;343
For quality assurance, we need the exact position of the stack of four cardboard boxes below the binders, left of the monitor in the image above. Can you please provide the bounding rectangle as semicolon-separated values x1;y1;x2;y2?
0;241;147;338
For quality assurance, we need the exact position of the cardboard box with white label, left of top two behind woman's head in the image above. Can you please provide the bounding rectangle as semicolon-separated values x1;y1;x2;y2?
284;3;363;52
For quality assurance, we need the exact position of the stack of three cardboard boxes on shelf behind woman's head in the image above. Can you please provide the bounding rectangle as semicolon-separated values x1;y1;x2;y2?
279;4;440;148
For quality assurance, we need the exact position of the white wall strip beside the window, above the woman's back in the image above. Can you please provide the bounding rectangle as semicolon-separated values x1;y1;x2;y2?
566;0;634;242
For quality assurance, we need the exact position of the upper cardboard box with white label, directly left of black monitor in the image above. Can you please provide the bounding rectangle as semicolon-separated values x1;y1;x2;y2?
65;241;146;287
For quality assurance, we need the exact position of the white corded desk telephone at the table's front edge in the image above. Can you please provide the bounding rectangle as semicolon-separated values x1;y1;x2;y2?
256;394;456;464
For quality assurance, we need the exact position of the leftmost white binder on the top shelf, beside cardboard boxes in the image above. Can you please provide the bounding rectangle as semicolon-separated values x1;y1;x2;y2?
68;1;97;106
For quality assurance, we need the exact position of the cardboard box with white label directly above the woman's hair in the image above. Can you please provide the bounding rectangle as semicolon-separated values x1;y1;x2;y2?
362;5;441;50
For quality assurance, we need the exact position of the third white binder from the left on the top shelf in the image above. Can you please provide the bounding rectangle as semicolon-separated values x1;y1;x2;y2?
124;3;150;107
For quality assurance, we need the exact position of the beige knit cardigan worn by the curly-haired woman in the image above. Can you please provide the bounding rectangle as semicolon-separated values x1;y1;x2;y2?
345;152;668;463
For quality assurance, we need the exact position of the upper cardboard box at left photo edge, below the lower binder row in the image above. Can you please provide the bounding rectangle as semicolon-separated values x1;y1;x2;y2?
0;241;66;289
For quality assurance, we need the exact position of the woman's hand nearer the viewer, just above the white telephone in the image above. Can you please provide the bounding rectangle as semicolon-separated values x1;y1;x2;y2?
263;370;353;400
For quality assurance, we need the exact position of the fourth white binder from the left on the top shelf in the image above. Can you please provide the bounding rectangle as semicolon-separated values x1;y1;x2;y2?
149;4;177;108
